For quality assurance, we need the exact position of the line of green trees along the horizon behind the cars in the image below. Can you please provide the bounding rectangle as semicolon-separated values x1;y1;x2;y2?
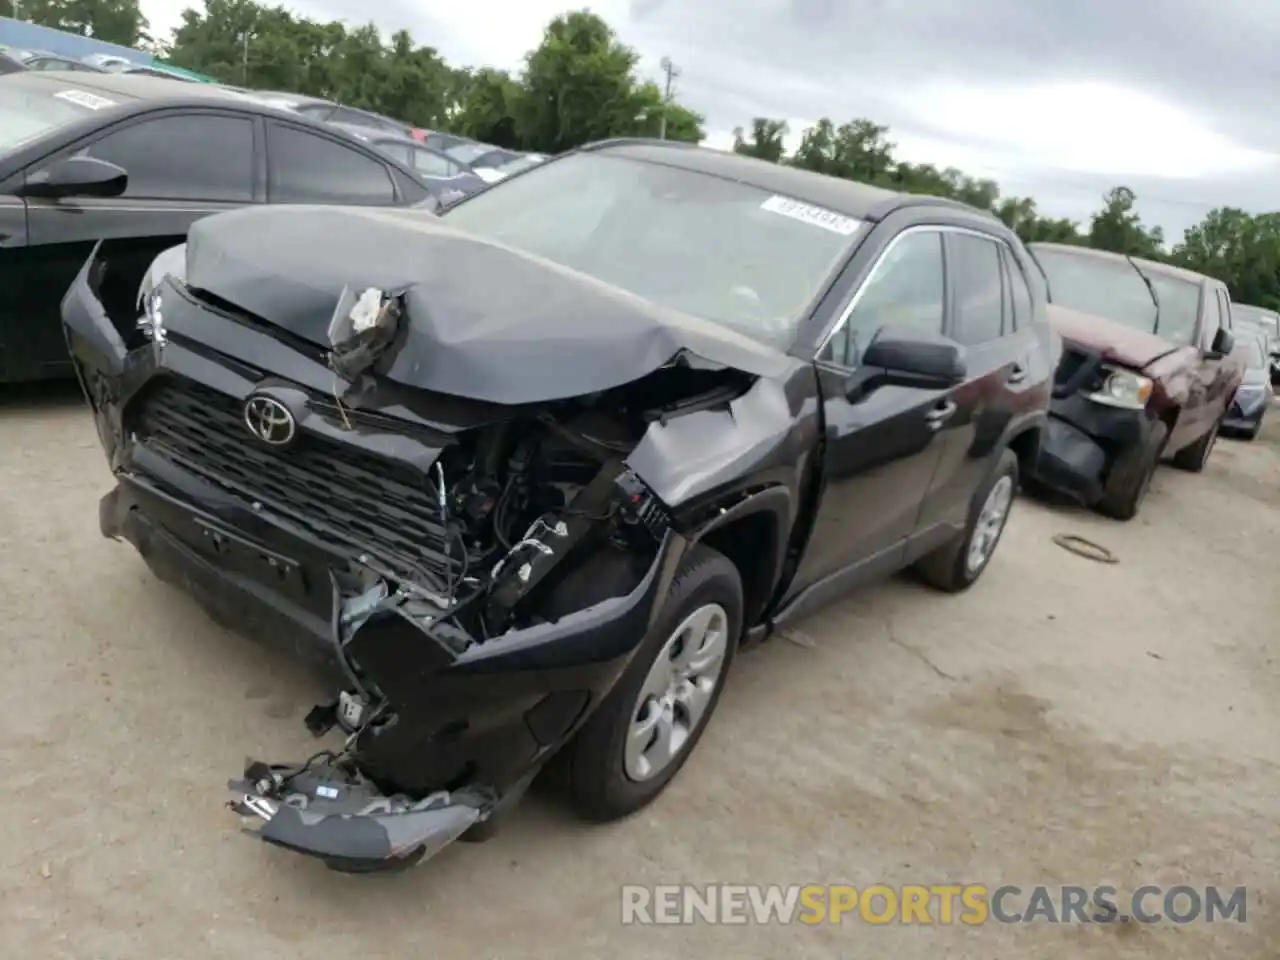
22;0;1280;307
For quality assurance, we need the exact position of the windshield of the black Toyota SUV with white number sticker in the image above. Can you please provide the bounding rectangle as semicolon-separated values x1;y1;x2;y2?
447;152;863;347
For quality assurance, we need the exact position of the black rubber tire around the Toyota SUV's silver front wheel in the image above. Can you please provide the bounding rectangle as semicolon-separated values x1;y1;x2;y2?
566;545;742;822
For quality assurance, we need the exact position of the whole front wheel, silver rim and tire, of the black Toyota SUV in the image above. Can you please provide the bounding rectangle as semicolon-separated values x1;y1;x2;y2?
567;547;742;822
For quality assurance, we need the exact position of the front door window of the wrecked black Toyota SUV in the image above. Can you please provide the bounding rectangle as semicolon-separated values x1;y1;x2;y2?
823;230;947;366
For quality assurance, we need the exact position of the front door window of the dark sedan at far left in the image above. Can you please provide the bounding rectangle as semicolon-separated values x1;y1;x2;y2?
83;114;253;204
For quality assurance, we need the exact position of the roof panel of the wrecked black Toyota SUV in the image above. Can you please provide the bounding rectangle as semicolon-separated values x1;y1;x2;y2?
586;138;995;220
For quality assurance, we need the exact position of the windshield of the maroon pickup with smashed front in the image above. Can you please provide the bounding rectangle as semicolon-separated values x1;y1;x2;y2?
1032;247;1156;333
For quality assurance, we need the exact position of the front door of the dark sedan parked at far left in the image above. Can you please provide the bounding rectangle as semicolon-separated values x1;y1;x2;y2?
22;110;261;379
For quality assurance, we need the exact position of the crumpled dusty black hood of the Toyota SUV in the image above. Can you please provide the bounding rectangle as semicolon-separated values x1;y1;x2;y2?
175;206;790;404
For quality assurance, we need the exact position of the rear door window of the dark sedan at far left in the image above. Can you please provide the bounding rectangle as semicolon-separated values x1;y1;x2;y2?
266;123;396;206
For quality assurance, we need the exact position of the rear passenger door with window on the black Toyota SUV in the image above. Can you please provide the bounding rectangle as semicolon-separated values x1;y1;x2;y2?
919;229;1036;532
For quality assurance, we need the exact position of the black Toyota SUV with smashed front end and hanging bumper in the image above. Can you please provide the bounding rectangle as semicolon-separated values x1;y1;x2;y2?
63;141;1060;870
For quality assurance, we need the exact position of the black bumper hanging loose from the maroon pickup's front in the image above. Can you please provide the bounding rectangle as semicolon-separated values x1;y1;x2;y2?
1033;396;1151;506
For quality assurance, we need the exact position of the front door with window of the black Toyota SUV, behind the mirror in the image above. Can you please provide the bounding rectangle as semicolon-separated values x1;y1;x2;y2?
792;228;947;593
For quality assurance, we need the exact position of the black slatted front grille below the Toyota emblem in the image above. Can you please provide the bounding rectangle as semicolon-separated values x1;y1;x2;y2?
133;381;458;580
